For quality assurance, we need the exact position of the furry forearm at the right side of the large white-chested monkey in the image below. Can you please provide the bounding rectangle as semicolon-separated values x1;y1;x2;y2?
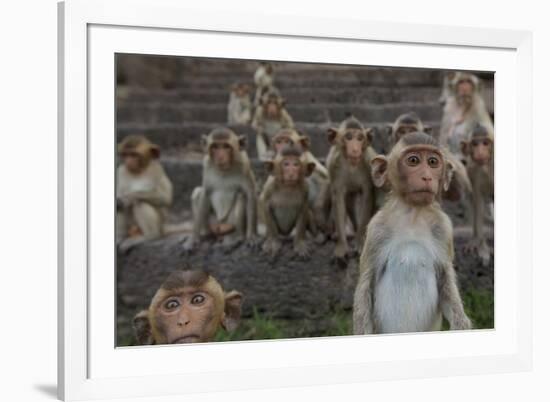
438;261;472;330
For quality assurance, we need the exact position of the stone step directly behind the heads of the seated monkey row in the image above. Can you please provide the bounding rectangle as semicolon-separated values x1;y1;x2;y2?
117;120;439;157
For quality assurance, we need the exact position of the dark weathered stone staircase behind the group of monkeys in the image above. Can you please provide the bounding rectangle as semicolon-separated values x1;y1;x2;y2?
116;55;493;220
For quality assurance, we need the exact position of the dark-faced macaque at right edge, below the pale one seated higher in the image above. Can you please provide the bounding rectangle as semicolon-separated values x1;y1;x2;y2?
461;125;494;266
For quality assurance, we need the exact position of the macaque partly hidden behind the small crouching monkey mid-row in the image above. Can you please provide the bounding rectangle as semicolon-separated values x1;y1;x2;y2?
271;129;329;232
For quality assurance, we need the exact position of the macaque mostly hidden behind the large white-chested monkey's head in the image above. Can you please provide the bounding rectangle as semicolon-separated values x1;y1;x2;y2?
390;112;472;201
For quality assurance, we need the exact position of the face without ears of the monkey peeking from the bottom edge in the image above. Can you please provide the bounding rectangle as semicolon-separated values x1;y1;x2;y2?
155;287;223;343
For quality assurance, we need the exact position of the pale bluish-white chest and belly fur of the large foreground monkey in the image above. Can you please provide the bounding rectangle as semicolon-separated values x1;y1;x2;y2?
374;222;441;333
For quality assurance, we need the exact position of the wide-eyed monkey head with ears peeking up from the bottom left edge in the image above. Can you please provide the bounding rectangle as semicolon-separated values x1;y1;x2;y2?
133;270;243;345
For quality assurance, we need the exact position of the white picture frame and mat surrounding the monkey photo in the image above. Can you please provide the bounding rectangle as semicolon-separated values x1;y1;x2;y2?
58;0;532;400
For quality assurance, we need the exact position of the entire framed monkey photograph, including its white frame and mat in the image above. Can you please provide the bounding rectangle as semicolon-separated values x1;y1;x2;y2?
58;0;532;400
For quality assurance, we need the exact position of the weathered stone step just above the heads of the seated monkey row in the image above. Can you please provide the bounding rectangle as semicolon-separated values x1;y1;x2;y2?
117;99;441;124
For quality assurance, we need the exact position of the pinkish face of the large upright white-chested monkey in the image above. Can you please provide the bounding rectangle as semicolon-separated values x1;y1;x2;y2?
399;148;444;206
